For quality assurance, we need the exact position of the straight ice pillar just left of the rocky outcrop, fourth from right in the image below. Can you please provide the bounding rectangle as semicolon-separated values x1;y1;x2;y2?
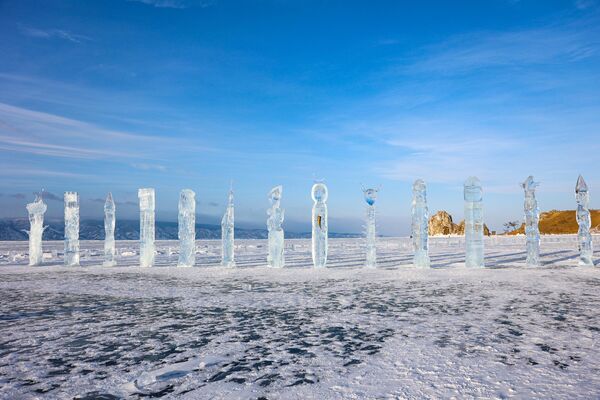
412;179;430;268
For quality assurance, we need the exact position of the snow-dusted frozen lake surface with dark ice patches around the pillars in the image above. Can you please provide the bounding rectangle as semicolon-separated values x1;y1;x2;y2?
0;235;600;399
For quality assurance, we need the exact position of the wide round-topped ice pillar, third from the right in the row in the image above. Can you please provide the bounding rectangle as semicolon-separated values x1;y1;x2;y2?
464;176;484;268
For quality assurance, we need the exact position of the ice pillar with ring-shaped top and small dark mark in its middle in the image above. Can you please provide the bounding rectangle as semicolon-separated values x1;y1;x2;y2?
311;182;327;268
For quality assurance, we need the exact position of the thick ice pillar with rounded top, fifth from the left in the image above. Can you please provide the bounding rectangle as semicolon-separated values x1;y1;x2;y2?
177;189;196;267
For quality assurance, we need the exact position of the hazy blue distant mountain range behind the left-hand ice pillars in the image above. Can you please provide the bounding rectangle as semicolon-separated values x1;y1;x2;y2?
0;218;361;240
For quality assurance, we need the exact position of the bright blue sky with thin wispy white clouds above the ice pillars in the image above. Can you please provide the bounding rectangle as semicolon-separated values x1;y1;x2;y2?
0;0;600;235
